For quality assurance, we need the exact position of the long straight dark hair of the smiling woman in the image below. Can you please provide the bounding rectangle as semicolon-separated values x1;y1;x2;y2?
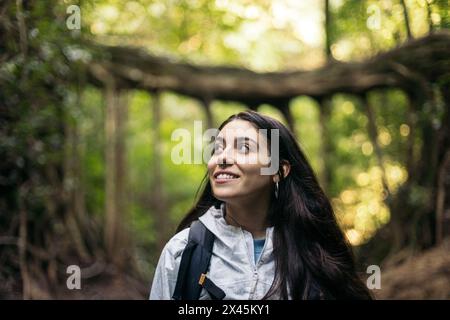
177;111;371;299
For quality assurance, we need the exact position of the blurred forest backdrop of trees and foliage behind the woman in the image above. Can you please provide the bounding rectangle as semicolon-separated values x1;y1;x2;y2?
0;0;450;298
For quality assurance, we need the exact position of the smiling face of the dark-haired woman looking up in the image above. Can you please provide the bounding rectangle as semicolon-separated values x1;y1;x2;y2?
208;119;274;202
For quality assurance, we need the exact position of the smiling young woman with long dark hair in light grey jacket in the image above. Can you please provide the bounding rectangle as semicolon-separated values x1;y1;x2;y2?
150;111;371;300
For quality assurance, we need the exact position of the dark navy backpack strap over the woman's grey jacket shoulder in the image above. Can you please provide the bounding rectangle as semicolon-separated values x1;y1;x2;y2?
172;220;225;300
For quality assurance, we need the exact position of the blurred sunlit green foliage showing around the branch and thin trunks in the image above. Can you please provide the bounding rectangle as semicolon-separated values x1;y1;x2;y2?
0;0;450;296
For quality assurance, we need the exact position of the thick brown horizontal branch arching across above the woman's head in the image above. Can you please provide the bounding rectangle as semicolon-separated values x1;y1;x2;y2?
88;31;450;105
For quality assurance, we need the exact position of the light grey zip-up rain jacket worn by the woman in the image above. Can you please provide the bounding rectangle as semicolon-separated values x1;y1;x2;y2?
150;204;275;300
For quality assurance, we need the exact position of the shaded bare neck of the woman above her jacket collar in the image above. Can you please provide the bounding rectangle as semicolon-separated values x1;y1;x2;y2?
225;195;269;239
